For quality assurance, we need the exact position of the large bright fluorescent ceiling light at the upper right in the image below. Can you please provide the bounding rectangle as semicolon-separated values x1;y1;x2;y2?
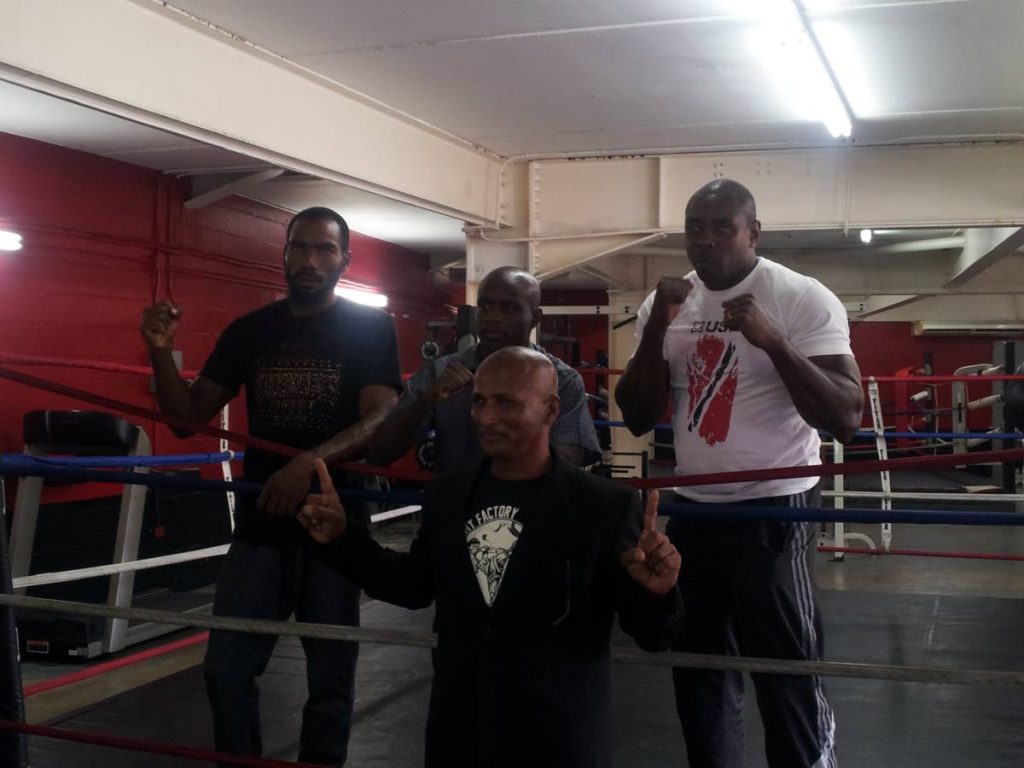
730;0;853;138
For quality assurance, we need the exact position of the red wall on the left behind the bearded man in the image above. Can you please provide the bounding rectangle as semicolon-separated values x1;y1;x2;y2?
0;134;450;501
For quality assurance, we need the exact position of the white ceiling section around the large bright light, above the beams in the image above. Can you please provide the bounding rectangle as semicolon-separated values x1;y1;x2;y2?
170;0;1024;157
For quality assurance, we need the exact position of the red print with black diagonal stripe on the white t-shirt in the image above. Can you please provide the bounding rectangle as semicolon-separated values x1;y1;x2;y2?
686;336;739;445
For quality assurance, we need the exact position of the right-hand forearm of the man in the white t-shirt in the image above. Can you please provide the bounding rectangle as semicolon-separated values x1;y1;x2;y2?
768;340;864;442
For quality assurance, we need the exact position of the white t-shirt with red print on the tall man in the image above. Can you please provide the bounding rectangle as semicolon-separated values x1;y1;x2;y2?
636;258;852;503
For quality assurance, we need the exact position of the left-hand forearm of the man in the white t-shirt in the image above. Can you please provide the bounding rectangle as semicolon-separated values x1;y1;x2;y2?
615;324;669;435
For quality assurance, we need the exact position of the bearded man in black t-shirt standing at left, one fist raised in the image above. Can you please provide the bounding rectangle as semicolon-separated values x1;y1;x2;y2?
141;208;401;766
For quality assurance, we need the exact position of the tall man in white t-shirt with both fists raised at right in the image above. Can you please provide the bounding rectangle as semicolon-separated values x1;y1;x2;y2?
615;180;863;768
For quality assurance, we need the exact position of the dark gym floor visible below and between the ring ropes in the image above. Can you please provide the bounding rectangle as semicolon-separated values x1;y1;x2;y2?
23;475;1024;768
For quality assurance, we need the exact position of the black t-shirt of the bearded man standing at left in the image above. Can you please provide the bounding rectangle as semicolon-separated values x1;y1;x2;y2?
201;298;402;543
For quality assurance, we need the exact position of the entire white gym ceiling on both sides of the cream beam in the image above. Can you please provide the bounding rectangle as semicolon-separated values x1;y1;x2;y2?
0;0;1024;307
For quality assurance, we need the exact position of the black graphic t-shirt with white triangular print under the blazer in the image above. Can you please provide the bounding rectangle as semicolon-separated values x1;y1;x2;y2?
465;472;546;606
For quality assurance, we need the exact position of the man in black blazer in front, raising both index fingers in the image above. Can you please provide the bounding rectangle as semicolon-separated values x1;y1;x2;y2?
298;346;682;768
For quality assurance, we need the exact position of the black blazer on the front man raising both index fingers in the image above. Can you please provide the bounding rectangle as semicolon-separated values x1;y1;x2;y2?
322;458;682;768
